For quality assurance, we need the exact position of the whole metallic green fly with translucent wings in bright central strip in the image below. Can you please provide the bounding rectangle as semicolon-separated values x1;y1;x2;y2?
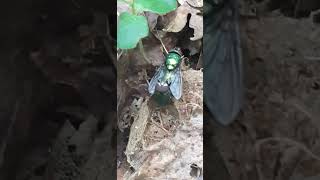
148;48;183;105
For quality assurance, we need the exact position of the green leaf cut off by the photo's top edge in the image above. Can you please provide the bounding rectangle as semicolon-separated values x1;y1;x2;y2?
133;0;177;15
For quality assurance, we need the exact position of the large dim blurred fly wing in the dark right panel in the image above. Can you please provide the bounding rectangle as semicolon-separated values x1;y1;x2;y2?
203;0;243;125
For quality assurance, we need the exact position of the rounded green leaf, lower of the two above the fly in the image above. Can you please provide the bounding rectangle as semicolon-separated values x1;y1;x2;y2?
117;12;149;49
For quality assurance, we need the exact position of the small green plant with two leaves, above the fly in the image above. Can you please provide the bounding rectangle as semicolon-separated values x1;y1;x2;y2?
117;0;177;49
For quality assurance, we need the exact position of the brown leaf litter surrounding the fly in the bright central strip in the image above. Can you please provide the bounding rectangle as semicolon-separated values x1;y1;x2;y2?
117;1;203;179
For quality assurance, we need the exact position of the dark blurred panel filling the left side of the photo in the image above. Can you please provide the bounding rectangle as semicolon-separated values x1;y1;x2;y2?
0;0;117;180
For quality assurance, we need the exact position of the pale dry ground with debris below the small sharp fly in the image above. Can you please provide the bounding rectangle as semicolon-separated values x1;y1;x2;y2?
117;65;203;179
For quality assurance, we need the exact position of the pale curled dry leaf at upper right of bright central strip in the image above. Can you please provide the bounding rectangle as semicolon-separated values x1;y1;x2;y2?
163;1;203;41
